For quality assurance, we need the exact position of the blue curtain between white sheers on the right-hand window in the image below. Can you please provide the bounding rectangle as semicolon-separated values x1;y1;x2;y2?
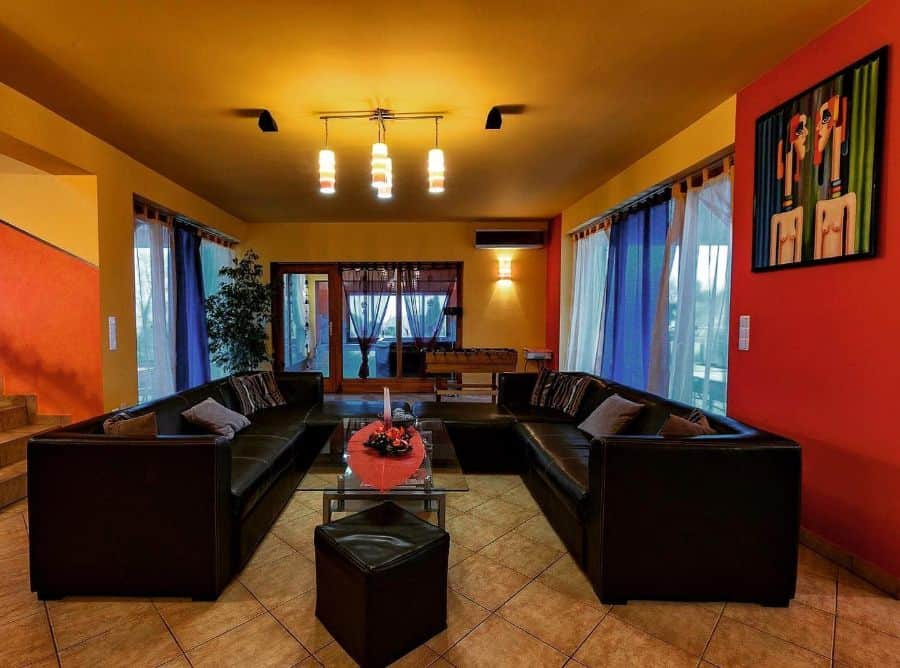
601;198;670;389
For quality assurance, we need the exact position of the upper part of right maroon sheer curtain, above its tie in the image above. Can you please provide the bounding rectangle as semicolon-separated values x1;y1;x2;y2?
398;265;458;349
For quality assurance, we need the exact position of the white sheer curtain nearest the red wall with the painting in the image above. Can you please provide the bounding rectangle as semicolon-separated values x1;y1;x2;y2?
654;170;732;413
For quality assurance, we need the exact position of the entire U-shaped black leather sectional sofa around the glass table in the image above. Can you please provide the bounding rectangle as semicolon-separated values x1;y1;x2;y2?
28;373;800;605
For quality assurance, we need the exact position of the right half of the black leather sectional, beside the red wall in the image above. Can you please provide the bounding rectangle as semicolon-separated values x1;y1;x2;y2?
413;373;801;606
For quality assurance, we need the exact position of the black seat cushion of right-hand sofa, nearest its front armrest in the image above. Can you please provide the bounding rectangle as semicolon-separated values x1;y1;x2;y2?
516;422;591;516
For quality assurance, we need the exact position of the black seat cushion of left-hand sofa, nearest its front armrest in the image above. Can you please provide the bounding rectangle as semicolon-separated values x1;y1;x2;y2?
231;431;294;517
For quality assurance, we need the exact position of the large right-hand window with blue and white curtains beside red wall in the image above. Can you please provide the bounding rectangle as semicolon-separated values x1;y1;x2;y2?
567;166;732;413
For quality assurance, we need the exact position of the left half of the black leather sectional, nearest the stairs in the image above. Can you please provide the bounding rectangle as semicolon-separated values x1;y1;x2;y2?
28;372;409;599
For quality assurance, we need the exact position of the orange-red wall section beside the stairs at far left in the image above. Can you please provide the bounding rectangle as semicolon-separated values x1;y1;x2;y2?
0;222;103;420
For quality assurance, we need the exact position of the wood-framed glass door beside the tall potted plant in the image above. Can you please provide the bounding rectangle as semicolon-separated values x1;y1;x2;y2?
272;263;343;392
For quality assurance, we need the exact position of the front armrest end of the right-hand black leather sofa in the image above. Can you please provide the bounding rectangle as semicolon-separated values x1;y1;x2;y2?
586;432;801;605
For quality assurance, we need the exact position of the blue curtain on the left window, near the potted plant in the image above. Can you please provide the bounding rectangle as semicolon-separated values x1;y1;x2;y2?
175;224;210;392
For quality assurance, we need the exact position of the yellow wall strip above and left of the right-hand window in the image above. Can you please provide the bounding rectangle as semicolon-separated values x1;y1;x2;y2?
559;96;737;368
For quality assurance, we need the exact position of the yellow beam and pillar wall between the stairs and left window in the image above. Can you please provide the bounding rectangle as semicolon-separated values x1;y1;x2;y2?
0;84;245;408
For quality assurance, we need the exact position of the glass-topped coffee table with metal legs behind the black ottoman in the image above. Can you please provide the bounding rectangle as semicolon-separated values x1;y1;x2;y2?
297;417;469;528
